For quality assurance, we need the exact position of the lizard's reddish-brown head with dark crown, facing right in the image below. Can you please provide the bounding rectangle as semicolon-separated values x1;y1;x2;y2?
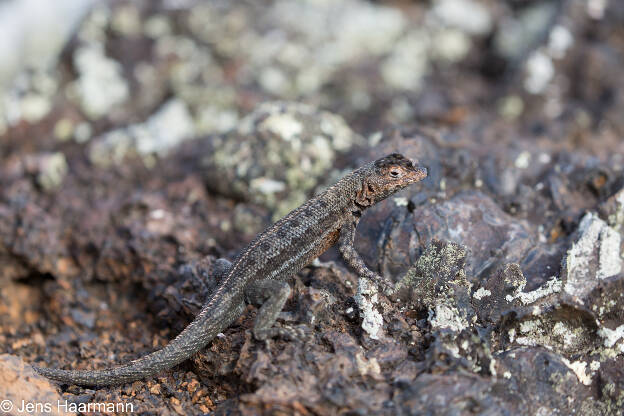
355;153;427;206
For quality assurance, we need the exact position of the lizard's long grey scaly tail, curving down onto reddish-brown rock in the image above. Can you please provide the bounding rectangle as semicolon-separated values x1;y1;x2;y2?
33;300;244;386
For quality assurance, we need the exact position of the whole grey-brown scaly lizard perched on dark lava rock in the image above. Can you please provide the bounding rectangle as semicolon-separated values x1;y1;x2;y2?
35;153;427;386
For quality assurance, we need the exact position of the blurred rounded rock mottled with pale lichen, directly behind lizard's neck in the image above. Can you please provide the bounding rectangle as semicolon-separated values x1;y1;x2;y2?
208;101;364;220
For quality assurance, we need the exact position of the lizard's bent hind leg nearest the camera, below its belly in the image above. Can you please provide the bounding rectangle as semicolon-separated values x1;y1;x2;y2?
245;279;305;341
